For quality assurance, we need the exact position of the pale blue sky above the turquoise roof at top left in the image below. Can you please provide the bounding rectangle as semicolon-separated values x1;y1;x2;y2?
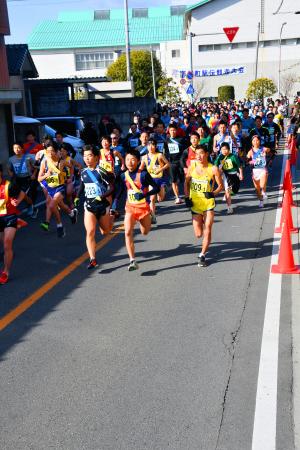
5;0;196;44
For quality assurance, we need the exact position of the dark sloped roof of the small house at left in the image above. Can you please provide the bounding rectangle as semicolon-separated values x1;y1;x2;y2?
5;44;39;78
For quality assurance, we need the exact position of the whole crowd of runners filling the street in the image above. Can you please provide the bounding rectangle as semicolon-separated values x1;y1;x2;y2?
0;99;299;284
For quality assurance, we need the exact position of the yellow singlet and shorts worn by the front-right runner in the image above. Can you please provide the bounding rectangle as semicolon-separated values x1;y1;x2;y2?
189;161;216;215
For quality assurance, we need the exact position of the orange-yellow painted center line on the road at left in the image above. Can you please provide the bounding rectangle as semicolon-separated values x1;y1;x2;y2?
0;225;124;331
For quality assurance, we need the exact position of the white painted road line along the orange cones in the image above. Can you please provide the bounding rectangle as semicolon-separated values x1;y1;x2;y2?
252;150;289;450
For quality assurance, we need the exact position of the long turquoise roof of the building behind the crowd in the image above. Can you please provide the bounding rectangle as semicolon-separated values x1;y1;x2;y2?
28;7;185;50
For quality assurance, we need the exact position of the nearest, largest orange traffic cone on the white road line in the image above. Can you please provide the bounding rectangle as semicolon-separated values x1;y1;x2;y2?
271;222;300;274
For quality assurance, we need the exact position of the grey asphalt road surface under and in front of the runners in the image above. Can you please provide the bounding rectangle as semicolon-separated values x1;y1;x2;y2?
0;152;294;450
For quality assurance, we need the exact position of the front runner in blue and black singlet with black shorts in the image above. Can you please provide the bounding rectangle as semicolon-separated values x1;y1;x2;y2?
74;145;114;270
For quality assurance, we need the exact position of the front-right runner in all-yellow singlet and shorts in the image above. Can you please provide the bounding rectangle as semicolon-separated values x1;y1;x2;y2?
185;146;224;267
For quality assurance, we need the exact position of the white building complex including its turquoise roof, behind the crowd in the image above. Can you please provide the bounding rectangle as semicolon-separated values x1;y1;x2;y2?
29;0;300;98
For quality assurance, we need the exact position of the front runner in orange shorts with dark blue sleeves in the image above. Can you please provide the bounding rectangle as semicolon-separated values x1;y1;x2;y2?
121;149;160;272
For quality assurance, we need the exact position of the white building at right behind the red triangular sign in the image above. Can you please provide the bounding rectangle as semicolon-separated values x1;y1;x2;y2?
178;0;300;98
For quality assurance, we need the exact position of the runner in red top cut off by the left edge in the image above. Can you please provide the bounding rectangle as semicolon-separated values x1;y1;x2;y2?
0;164;25;284
